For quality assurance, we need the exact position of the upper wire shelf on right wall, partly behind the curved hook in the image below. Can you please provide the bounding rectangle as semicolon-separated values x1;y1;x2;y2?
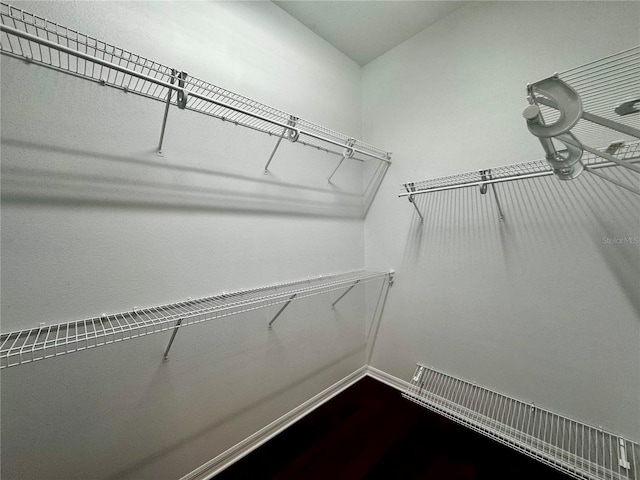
399;141;640;197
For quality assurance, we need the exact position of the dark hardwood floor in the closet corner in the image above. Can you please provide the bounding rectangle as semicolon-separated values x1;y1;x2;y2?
216;377;571;480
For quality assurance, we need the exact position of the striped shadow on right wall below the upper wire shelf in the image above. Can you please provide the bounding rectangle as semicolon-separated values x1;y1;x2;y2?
403;168;640;317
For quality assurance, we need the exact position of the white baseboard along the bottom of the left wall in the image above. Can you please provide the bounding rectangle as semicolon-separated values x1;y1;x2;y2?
180;365;368;480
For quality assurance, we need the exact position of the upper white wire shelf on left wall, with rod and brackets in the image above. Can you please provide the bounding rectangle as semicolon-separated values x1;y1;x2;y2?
0;2;391;184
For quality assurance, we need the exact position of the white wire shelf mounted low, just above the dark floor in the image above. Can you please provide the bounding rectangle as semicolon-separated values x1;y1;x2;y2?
403;364;640;480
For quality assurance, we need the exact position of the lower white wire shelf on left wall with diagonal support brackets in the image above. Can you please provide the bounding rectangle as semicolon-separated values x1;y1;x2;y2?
0;270;393;368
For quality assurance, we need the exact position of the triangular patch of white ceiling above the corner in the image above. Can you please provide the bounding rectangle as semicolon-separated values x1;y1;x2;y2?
274;0;467;65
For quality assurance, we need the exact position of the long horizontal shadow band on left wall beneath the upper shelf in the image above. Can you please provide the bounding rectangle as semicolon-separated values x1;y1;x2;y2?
2;139;387;218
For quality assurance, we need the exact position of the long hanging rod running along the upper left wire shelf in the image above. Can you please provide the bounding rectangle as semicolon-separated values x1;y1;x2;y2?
0;24;391;163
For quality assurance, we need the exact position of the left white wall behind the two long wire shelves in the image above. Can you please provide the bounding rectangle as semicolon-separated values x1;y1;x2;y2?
2;1;378;480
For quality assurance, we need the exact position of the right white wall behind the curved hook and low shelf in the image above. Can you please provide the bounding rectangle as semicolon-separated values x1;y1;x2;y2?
363;2;640;440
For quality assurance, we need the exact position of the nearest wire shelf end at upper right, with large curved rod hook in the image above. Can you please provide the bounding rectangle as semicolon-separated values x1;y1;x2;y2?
523;46;640;189
